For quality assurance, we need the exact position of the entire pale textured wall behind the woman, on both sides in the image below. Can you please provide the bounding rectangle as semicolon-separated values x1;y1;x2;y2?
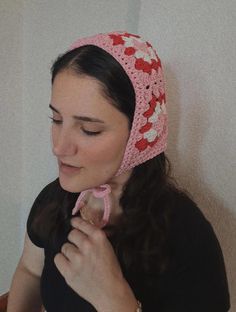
0;0;236;311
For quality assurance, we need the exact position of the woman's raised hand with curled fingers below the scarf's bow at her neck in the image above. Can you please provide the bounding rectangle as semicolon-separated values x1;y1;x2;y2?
54;217;136;311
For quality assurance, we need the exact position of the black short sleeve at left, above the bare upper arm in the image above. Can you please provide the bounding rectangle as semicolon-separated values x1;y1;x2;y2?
26;179;59;248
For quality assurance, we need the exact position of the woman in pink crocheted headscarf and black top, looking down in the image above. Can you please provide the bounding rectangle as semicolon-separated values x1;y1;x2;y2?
8;32;229;312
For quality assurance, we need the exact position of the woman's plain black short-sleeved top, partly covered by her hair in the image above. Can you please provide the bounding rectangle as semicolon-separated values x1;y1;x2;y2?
27;179;229;312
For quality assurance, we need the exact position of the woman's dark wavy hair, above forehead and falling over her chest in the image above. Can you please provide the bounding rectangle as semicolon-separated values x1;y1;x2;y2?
36;45;188;273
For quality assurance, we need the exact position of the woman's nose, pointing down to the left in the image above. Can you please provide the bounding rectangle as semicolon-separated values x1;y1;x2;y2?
52;130;77;157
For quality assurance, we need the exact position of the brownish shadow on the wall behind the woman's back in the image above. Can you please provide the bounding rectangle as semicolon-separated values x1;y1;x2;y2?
165;66;236;312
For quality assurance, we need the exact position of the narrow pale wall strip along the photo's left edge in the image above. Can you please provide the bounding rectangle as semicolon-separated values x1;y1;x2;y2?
0;0;23;293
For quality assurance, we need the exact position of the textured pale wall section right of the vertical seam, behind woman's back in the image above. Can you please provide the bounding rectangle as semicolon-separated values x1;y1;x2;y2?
139;0;236;311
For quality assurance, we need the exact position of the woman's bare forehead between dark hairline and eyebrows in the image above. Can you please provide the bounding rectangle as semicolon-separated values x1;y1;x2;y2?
51;71;127;121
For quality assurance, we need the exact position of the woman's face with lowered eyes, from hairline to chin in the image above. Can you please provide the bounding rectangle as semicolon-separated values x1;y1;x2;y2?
50;70;129;192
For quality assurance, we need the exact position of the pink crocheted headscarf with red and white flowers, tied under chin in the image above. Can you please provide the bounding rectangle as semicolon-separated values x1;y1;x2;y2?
70;31;168;224
